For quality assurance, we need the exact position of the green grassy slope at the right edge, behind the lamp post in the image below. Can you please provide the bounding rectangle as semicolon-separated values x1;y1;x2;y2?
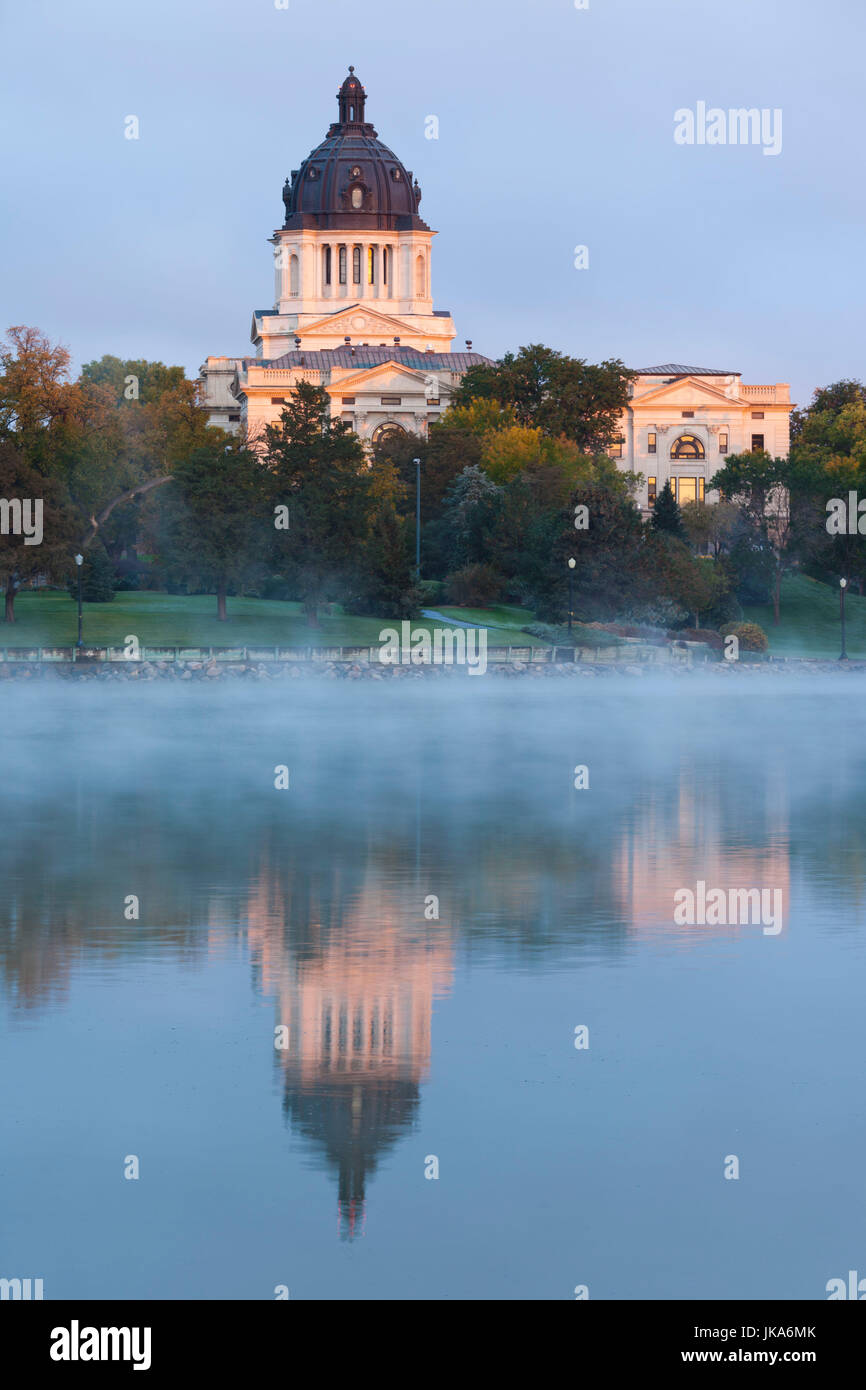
744;574;866;659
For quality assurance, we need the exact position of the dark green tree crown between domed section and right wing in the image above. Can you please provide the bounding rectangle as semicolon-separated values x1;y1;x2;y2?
452;343;634;453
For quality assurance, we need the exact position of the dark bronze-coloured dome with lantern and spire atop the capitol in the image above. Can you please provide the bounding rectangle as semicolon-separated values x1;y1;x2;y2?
282;68;430;232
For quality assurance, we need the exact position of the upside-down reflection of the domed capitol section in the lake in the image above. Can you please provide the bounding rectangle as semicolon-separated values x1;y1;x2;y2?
247;866;453;1238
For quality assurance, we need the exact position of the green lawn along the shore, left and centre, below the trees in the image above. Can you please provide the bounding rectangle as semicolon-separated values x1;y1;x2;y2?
0;589;546;646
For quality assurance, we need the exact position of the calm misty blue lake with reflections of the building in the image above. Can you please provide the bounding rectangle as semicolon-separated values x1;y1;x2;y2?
0;676;866;1300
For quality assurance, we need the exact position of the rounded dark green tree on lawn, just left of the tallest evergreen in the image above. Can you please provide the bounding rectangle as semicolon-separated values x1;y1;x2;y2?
163;443;274;623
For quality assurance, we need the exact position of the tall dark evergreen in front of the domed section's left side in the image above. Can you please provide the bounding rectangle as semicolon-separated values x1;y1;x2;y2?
265;381;371;627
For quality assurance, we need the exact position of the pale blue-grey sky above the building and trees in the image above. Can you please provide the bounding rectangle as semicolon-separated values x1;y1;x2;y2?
0;0;866;404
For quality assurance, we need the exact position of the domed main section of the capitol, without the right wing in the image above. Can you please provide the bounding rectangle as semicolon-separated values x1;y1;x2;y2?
202;68;488;443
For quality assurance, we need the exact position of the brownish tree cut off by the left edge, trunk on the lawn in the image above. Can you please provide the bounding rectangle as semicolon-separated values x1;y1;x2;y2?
0;439;78;623
